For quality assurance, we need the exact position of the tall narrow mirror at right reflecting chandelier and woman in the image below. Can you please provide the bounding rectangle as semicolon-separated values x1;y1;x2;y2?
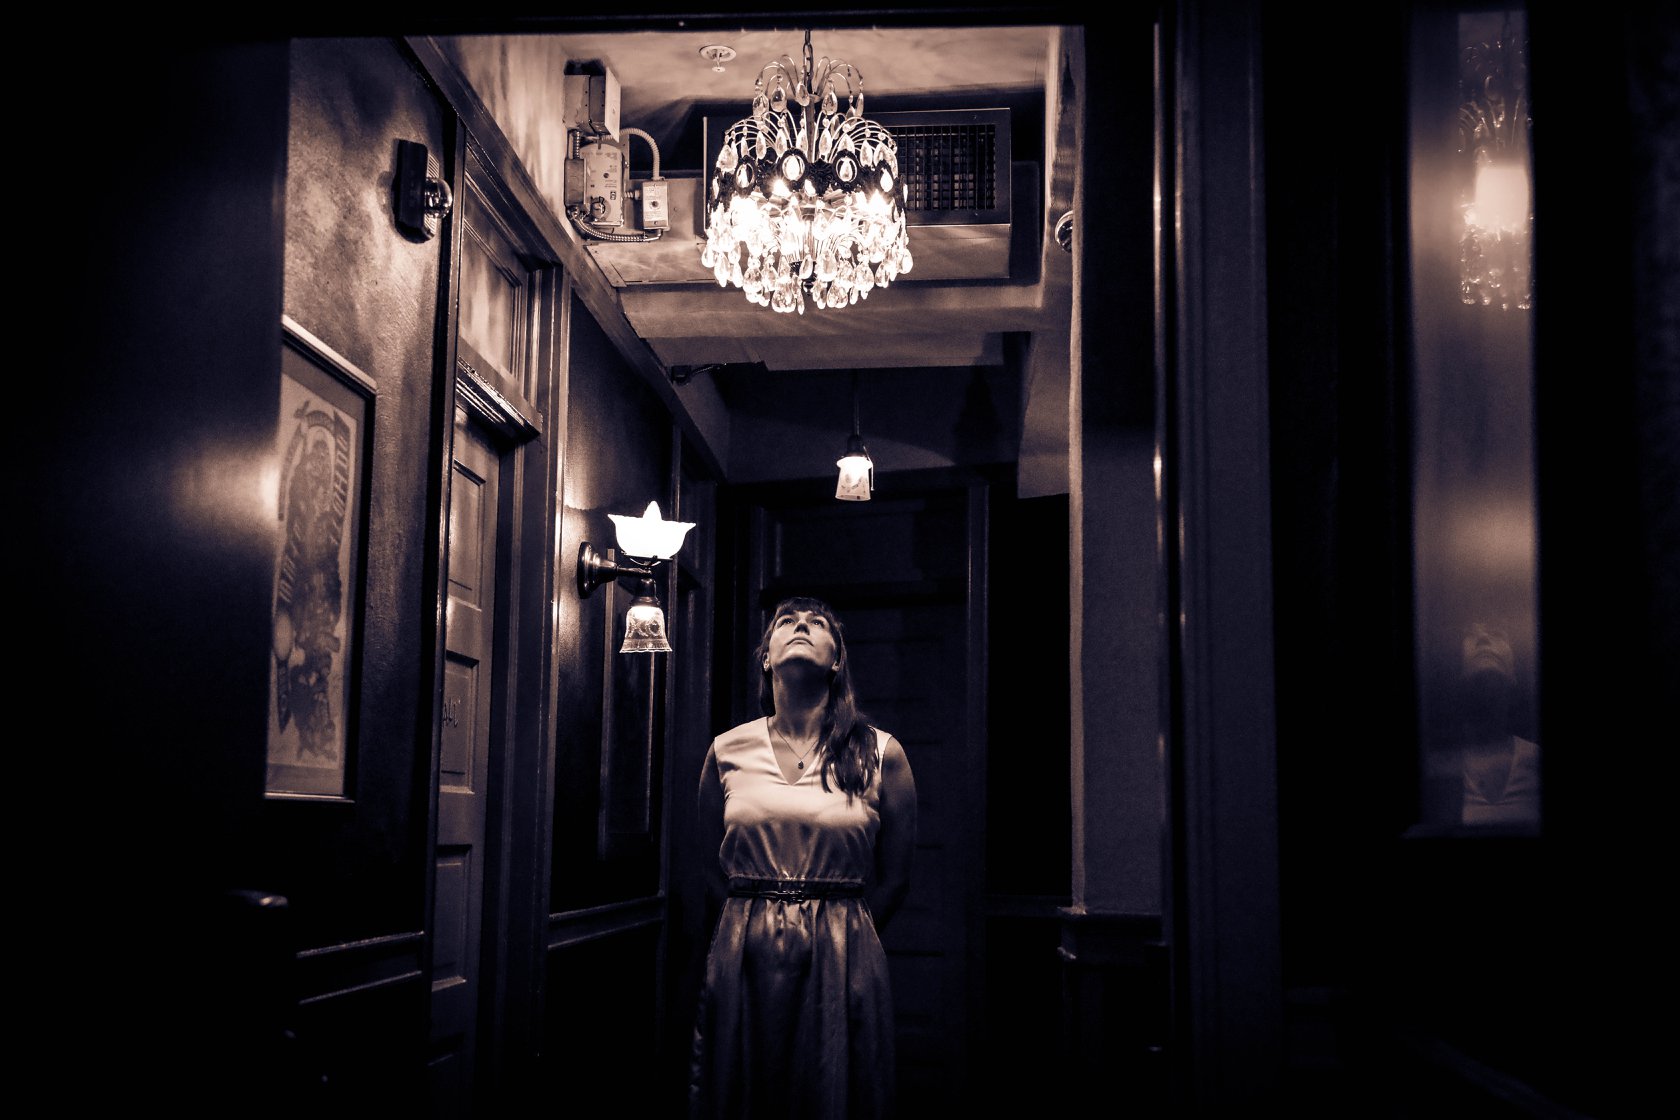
1410;8;1541;831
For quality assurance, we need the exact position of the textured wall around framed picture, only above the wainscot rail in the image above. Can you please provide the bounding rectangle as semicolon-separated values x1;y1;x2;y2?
264;40;444;953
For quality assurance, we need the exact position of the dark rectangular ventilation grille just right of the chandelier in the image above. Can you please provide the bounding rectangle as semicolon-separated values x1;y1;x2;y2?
872;109;1010;225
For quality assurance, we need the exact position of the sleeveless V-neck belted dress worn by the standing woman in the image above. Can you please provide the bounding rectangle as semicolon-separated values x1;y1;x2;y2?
689;719;894;1120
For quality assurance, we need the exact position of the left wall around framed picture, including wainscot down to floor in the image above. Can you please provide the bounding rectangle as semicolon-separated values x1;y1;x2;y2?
260;39;449;1098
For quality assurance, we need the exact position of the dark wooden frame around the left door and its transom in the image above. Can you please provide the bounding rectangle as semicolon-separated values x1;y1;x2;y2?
422;114;571;1105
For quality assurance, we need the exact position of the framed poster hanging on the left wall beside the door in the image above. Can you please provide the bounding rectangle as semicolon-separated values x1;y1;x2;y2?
265;319;375;801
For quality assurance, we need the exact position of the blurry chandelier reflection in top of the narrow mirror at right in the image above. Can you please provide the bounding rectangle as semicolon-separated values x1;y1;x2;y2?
1458;12;1534;311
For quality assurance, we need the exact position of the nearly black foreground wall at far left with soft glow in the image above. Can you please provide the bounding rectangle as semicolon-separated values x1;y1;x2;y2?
55;37;286;1112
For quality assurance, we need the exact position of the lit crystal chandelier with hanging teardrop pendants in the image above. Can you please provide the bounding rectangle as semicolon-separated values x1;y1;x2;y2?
701;32;911;314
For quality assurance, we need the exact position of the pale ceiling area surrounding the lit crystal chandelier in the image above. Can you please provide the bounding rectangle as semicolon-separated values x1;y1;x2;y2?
524;27;1072;379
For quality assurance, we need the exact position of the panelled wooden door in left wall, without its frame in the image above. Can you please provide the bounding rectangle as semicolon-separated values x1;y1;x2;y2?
430;413;501;1117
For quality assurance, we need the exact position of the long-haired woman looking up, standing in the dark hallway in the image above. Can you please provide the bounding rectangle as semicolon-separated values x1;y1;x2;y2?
689;598;916;1120
